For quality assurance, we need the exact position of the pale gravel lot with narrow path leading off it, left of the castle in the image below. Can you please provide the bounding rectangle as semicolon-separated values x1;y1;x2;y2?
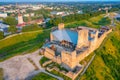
0;50;63;80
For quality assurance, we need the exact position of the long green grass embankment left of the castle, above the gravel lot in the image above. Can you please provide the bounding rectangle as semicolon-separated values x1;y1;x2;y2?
0;31;50;61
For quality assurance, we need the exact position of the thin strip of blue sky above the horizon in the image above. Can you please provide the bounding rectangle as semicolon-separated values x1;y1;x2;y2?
0;0;120;2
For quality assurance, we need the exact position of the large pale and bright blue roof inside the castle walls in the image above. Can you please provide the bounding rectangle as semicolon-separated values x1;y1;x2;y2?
52;29;78;44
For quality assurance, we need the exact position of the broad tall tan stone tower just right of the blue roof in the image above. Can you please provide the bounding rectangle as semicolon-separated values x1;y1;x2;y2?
77;29;88;48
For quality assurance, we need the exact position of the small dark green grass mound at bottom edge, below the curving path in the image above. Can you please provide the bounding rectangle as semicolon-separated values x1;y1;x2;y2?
32;72;57;80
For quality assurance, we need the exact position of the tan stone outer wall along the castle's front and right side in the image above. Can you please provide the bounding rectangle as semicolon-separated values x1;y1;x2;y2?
44;29;112;69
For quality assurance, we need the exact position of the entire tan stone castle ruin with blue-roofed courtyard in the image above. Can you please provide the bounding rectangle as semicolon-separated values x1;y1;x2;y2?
43;23;112;70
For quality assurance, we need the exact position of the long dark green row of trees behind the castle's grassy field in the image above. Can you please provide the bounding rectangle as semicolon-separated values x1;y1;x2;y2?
47;11;105;26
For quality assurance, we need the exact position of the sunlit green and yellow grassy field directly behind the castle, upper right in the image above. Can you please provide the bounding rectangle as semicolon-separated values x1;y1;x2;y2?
65;15;110;28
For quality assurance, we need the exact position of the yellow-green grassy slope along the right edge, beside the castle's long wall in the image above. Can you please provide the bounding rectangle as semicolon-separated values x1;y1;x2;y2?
81;24;120;80
